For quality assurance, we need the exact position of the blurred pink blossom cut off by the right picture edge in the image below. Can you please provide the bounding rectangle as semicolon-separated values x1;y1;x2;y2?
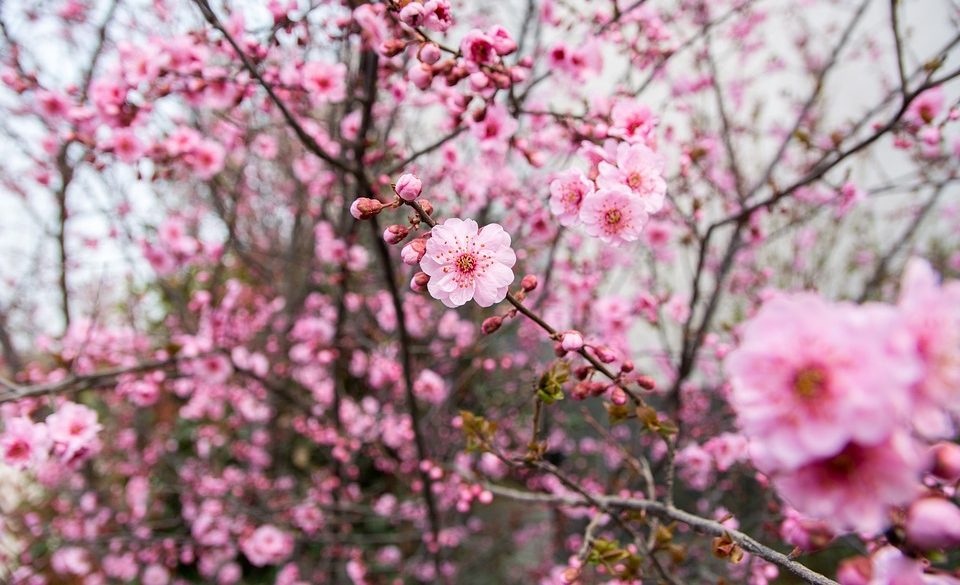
899;259;960;438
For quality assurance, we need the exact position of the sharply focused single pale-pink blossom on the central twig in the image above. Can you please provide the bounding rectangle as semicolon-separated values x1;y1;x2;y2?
420;218;517;307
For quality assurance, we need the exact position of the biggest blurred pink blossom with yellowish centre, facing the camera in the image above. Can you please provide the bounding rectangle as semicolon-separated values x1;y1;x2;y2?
726;293;920;472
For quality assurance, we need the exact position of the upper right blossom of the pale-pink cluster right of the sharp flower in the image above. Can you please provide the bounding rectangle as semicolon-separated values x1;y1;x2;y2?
597;142;667;213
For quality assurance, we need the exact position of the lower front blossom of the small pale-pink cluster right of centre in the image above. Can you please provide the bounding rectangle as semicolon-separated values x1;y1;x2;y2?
580;185;648;245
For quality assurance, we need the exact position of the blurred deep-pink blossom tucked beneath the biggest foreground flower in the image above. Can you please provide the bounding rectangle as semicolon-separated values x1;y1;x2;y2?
773;433;926;534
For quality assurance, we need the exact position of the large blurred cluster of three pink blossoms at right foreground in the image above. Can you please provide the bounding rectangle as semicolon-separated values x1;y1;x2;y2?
726;260;960;534
